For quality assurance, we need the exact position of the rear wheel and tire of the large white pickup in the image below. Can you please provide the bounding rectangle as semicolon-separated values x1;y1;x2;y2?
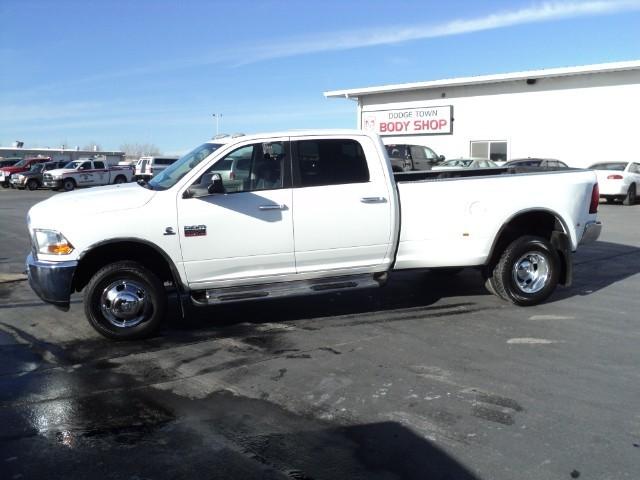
490;235;561;306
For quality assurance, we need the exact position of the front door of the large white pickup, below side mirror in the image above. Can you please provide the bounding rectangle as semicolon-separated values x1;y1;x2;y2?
177;139;295;289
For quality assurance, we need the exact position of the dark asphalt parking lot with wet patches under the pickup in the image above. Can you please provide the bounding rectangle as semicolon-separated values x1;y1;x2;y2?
0;190;640;480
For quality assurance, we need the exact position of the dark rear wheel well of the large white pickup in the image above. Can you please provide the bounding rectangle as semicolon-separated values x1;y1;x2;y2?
485;210;570;283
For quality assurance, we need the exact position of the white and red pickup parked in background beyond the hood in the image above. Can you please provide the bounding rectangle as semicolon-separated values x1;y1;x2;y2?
43;158;133;192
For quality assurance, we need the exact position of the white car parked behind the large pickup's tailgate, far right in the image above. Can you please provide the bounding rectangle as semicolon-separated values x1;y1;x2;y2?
589;162;640;205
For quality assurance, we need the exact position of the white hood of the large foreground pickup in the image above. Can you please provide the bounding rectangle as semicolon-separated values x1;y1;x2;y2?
29;183;157;229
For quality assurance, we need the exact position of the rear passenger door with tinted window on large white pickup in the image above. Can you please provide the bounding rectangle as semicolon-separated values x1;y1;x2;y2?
292;137;395;273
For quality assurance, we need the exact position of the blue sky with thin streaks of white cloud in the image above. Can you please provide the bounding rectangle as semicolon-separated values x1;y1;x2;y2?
0;0;640;154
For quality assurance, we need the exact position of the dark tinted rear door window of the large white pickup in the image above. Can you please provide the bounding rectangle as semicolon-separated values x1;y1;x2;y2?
296;140;369;187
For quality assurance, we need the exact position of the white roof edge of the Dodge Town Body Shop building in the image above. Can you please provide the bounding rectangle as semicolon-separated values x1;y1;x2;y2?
324;60;640;98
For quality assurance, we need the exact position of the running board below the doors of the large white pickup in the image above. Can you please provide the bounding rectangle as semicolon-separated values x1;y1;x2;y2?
191;272;388;306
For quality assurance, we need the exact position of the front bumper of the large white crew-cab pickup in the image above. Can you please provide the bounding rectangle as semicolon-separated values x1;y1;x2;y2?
26;253;78;311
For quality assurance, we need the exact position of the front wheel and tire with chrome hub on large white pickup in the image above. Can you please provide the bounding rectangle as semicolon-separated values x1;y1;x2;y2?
84;261;167;340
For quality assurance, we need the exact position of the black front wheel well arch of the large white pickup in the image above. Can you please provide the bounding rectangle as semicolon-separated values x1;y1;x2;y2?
73;241;179;292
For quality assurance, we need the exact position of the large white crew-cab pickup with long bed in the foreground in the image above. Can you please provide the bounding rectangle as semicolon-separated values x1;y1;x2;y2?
27;131;601;339
